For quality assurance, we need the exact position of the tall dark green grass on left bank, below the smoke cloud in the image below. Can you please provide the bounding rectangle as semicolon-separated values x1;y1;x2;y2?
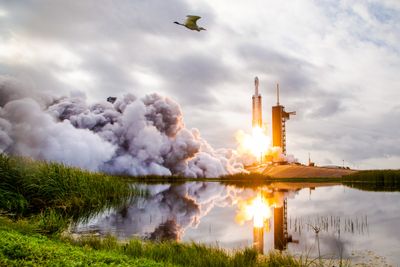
0;154;144;221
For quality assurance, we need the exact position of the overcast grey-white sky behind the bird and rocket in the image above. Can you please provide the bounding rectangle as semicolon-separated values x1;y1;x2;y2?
0;0;400;169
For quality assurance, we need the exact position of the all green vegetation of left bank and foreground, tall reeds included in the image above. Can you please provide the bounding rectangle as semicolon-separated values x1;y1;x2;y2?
0;155;302;267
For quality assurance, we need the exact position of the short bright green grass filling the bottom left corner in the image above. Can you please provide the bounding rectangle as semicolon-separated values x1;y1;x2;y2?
0;218;173;267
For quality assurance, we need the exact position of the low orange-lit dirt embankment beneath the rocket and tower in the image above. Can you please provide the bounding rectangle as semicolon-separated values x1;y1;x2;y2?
256;165;356;178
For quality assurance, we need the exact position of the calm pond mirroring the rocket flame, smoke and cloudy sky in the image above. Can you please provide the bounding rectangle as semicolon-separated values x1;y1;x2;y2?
72;182;400;265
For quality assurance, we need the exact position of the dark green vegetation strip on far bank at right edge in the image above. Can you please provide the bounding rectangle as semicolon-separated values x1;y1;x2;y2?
342;170;400;191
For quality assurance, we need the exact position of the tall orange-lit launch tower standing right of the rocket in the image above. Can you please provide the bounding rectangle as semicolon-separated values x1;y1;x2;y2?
274;84;296;155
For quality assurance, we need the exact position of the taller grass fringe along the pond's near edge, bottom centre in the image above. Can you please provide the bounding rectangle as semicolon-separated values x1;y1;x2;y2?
69;236;306;267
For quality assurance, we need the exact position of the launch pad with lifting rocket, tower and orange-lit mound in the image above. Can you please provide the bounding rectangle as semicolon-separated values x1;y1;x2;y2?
245;77;355;178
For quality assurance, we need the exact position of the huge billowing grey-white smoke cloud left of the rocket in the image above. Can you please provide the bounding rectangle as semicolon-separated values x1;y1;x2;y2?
0;77;243;177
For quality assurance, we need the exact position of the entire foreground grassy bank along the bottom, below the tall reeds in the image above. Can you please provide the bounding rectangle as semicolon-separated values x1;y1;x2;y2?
0;217;304;267
